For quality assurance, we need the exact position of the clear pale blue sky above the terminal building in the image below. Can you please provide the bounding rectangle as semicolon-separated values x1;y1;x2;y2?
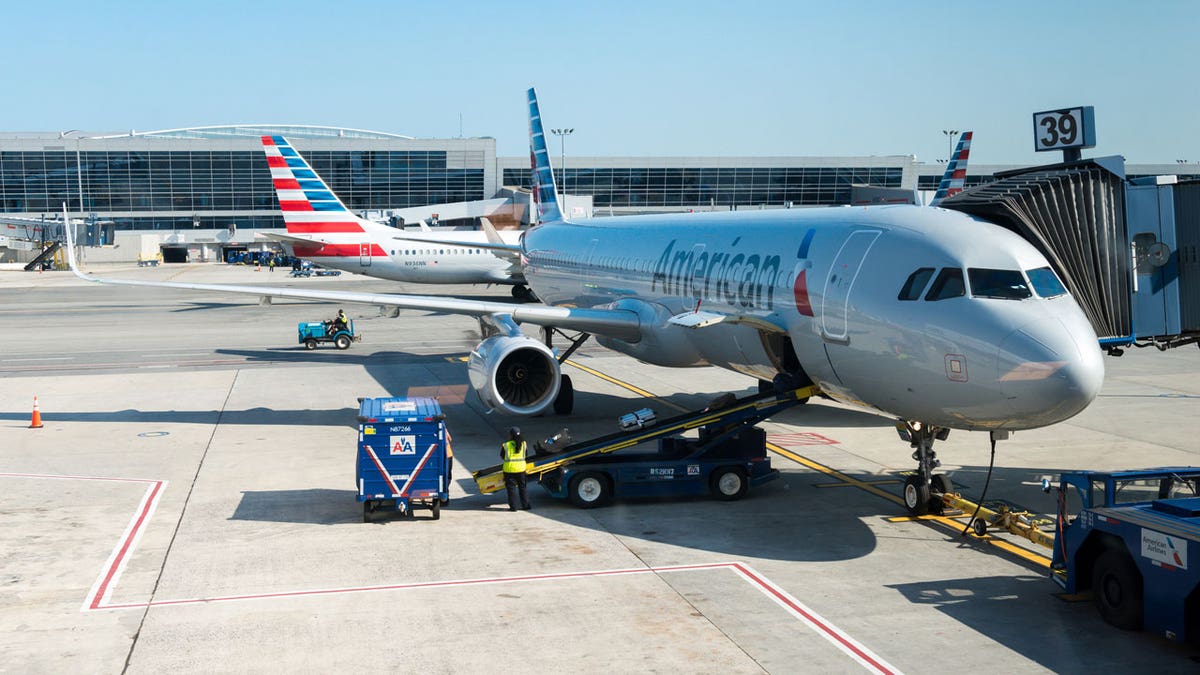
11;0;1200;163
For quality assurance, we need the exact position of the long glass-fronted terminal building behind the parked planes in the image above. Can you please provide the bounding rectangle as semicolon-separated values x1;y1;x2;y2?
0;125;1200;262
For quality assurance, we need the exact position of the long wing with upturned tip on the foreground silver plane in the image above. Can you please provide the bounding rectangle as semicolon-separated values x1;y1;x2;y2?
58;212;641;340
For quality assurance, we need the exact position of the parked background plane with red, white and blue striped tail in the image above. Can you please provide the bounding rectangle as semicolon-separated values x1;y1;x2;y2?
263;136;532;299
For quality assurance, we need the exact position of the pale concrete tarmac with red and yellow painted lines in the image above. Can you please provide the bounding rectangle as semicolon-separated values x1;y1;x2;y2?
0;264;1200;674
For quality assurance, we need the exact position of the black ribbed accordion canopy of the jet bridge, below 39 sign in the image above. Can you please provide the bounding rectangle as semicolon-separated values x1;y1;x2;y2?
941;157;1133;342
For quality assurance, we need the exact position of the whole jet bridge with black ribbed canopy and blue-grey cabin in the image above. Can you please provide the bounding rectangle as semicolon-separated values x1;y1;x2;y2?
942;156;1200;348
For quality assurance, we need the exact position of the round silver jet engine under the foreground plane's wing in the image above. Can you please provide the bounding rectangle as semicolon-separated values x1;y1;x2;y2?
467;335;562;416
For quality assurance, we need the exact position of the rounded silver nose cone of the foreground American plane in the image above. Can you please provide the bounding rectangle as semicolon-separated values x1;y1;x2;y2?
997;315;1104;428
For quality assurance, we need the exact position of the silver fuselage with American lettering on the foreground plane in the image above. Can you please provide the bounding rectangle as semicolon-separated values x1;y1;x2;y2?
524;201;1104;429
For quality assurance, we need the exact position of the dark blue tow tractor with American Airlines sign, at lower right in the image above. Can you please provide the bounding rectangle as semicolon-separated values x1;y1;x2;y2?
1048;467;1200;641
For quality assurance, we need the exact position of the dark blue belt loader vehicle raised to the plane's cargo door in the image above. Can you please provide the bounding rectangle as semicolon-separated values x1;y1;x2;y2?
474;387;817;508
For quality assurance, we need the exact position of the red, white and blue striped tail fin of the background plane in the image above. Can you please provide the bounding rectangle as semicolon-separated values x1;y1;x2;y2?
262;136;385;235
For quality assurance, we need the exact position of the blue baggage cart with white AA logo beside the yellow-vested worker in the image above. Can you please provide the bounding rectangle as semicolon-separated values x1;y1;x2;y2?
356;398;454;522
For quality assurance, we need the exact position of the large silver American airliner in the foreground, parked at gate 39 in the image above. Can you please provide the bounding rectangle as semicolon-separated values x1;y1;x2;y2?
60;89;1104;514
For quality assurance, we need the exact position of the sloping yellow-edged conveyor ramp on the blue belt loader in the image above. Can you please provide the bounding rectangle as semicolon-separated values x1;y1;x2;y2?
472;387;818;495
